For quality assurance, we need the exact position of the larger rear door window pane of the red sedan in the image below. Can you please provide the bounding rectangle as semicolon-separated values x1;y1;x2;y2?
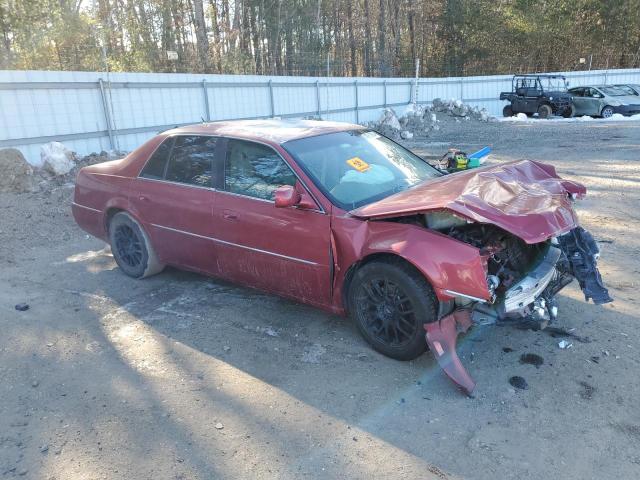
164;135;218;187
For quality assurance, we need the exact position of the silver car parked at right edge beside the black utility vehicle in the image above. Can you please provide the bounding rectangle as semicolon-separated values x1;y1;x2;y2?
569;85;640;118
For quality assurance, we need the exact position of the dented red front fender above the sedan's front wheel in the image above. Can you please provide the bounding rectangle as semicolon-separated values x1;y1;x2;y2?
333;216;491;312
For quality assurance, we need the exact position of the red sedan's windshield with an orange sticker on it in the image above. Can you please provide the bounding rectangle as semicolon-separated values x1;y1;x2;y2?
283;130;442;210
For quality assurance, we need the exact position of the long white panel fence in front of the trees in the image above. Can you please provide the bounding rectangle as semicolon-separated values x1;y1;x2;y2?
0;69;640;164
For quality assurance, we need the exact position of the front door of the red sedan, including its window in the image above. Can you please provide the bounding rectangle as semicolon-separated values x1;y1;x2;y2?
214;139;331;305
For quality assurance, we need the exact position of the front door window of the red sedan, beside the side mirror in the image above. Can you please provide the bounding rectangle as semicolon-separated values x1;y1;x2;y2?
225;140;297;200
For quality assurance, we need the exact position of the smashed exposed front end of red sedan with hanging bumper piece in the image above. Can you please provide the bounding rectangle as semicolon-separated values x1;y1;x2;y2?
425;224;613;394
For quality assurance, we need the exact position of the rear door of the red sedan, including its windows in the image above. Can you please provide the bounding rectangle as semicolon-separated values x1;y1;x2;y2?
130;135;219;274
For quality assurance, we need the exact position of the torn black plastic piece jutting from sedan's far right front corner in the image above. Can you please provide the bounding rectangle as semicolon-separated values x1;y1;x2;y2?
558;227;613;305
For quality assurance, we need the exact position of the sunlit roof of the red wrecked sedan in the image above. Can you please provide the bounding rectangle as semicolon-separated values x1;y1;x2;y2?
163;119;364;144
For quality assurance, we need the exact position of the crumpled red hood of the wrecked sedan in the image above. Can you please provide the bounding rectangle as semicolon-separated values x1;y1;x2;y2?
349;160;586;243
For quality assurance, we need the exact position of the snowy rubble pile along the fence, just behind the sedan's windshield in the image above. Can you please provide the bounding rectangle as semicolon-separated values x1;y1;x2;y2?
369;98;492;140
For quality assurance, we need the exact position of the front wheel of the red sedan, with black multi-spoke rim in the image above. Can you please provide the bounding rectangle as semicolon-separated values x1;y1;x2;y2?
347;261;438;360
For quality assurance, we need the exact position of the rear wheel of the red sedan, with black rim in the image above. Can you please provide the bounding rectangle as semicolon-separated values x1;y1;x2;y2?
109;212;164;278
